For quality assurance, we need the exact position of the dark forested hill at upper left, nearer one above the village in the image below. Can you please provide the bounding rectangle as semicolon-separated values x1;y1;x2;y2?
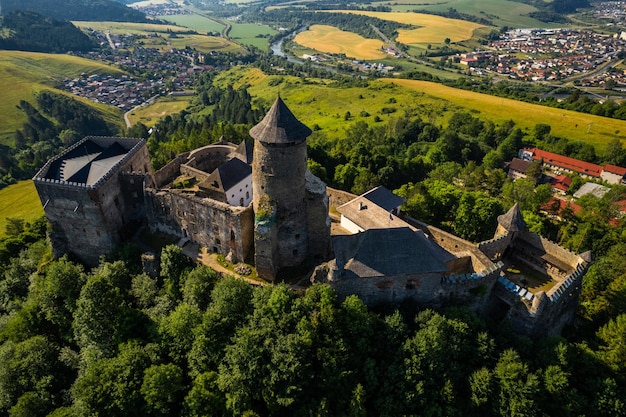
0;11;96;53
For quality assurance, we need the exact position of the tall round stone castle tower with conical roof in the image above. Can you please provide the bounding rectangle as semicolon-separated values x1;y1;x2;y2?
250;97;311;280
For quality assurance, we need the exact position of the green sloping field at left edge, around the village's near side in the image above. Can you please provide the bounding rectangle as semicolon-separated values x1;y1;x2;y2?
0;51;121;146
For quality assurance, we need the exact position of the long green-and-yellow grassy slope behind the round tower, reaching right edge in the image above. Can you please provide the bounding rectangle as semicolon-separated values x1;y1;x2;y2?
216;69;626;150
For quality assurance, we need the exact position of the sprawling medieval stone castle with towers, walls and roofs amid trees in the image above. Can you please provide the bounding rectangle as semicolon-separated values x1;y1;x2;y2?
33;97;591;336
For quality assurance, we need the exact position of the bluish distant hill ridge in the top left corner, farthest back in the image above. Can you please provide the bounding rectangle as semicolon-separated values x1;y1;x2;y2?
0;0;147;22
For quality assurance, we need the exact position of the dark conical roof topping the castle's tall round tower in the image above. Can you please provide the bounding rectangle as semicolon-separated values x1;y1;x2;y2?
250;96;311;144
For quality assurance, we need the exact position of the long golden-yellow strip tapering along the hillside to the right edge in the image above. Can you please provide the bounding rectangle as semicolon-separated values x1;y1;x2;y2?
385;78;626;149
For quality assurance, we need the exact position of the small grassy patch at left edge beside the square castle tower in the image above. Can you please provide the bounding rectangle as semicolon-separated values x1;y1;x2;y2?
0;180;43;237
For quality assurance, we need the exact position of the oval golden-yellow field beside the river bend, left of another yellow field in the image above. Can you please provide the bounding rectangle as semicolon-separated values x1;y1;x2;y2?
294;25;387;60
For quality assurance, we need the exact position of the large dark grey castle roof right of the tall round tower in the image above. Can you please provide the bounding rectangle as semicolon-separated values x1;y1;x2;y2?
333;227;448;278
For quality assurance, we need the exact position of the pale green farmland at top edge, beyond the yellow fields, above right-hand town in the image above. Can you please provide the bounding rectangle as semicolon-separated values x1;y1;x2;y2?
371;0;550;27
